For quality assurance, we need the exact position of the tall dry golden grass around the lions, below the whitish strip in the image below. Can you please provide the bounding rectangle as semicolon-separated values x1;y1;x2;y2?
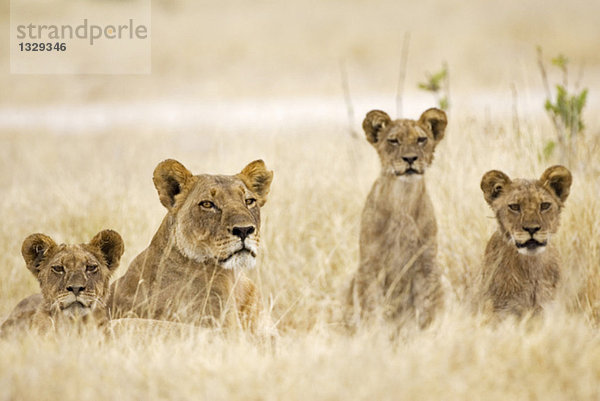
0;105;600;400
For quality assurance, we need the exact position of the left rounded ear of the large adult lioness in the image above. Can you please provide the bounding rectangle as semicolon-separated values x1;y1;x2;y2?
152;159;193;210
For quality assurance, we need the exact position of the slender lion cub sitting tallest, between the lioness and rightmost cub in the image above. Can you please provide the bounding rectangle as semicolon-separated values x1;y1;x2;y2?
349;108;447;328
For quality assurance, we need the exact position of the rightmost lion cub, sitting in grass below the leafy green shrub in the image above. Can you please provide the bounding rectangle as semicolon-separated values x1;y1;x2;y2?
480;166;572;317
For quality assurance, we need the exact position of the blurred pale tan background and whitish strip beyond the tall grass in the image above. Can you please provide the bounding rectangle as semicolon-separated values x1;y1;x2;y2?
0;0;600;130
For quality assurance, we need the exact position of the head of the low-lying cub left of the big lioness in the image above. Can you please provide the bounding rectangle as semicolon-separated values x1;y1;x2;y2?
21;230;124;317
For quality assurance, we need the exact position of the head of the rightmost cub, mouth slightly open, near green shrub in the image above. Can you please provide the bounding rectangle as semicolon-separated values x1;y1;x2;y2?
481;166;572;255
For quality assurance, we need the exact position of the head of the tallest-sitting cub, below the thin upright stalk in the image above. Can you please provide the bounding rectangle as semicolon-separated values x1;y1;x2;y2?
363;108;448;179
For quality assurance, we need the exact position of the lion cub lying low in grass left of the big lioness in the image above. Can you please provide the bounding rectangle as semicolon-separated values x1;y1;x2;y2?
1;230;124;335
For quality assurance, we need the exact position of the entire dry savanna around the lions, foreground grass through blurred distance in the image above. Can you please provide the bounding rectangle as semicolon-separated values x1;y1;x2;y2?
0;1;600;401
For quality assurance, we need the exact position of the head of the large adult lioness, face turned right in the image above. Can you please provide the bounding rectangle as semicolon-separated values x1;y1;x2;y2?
153;160;273;269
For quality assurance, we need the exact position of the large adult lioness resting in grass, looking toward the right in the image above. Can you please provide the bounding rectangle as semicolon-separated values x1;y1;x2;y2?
110;160;273;331
